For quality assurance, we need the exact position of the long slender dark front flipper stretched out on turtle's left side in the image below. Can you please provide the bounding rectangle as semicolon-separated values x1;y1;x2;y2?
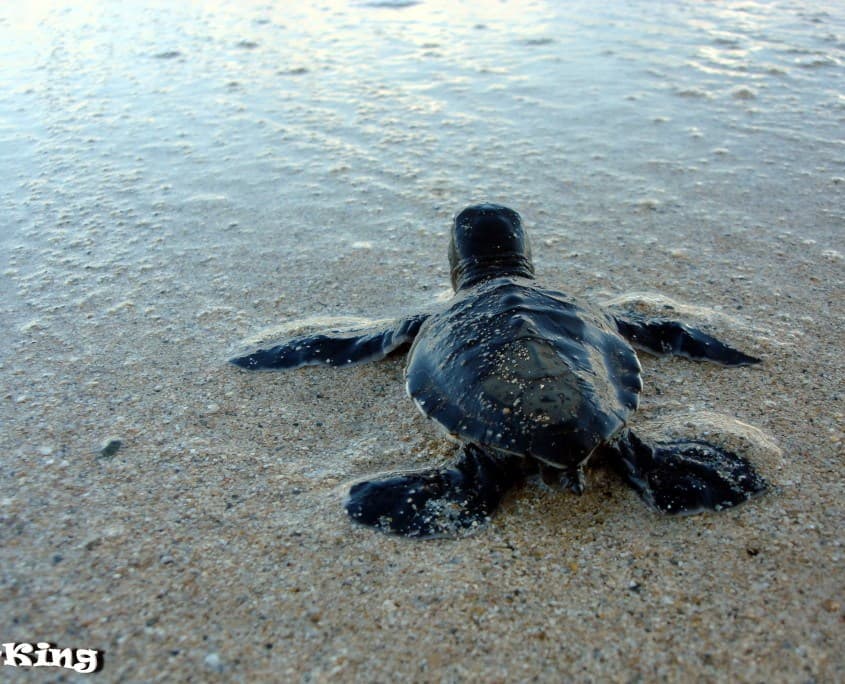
230;313;430;370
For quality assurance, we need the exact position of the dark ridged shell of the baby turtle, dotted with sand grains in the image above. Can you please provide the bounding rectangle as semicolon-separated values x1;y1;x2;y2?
405;278;642;468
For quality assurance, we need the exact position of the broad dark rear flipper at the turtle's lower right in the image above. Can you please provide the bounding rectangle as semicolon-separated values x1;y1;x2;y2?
612;430;766;515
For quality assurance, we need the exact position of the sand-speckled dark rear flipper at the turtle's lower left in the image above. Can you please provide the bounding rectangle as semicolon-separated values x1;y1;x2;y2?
346;444;521;538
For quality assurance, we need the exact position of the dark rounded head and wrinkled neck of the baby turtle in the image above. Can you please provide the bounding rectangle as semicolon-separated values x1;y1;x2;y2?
449;204;534;292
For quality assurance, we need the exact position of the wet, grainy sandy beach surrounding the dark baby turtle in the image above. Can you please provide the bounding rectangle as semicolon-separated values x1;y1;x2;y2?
0;0;845;683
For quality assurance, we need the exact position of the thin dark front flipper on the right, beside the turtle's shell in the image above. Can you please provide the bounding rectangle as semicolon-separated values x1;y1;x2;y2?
613;312;760;366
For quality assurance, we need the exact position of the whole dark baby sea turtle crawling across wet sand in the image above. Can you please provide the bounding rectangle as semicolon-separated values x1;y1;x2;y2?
232;204;766;537
